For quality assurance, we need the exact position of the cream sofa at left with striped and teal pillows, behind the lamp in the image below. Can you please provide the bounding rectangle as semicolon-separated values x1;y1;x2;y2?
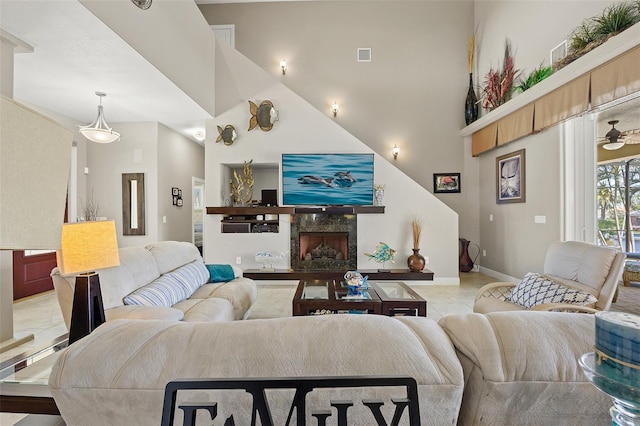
51;241;257;328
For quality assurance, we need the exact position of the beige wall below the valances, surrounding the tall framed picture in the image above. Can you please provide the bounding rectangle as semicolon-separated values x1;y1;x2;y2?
479;126;562;277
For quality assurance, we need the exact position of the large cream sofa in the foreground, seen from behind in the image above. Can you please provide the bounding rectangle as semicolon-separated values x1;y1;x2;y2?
49;312;611;426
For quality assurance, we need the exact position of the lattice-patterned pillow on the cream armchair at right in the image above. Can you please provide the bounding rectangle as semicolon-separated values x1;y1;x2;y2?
509;272;598;308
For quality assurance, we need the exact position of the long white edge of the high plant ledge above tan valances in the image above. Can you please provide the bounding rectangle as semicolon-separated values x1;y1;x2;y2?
459;23;640;141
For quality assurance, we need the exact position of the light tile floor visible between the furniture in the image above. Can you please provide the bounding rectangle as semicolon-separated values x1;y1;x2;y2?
0;272;496;426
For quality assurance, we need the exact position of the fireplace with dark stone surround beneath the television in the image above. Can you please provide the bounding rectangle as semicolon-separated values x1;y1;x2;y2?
291;213;358;271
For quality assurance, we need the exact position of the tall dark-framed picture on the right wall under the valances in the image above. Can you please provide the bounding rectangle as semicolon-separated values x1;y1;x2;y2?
496;149;526;204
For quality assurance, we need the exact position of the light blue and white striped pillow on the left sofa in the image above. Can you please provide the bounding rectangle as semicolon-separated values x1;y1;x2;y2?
123;274;193;307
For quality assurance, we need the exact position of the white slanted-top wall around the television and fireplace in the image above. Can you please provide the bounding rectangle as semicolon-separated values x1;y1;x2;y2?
204;83;459;283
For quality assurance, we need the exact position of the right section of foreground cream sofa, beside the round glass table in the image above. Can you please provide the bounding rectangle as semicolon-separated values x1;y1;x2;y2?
439;311;612;426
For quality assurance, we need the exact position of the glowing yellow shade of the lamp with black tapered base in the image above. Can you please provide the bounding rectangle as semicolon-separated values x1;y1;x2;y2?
56;220;120;274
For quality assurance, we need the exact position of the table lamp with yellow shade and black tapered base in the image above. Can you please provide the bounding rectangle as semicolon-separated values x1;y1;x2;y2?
56;220;120;344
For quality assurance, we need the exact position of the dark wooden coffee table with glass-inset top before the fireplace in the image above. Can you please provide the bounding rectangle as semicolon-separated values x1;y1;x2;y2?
292;280;427;316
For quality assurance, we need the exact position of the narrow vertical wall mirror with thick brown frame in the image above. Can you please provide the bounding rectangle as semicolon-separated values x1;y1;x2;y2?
122;173;145;235
